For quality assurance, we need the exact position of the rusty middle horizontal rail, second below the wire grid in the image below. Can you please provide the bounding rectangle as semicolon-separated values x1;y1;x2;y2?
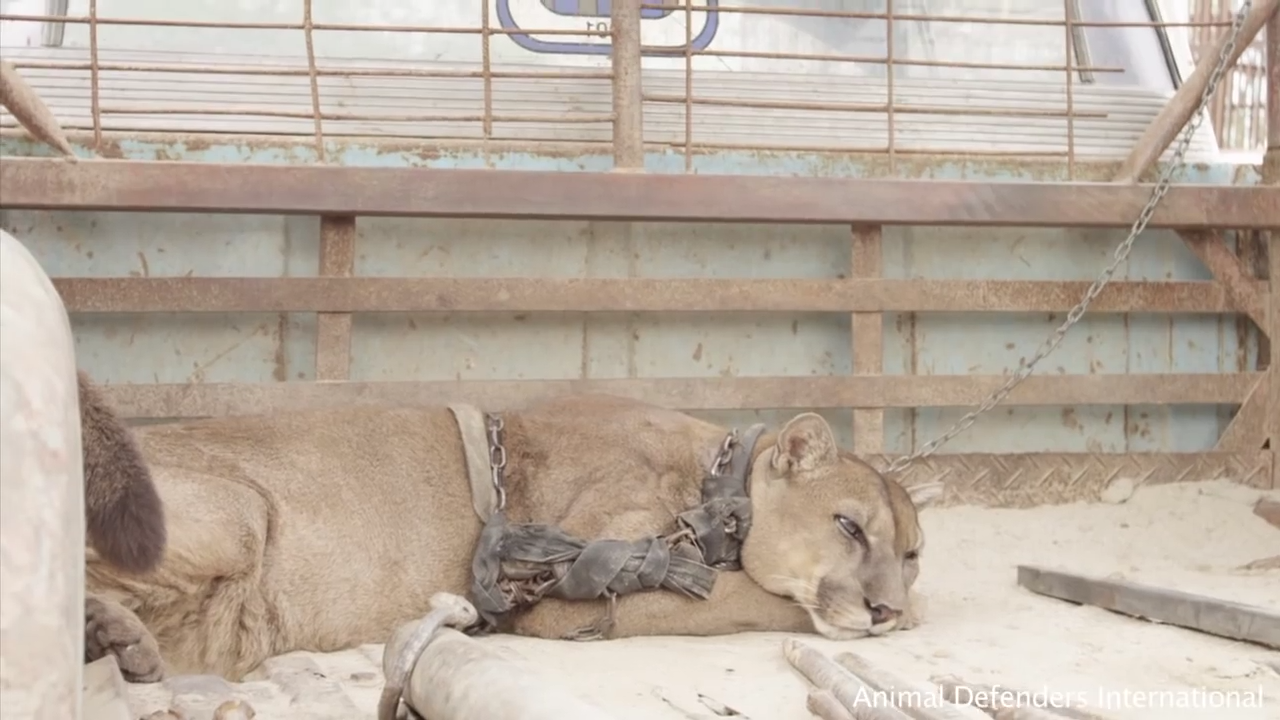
54;278;1267;314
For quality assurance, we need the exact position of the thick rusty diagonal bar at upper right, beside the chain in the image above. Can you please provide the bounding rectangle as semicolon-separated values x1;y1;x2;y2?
1115;0;1280;183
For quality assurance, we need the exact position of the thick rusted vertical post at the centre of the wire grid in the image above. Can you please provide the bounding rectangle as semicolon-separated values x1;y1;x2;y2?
609;0;644;172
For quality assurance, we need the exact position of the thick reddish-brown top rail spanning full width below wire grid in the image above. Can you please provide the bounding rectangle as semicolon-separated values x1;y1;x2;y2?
0;158;1280;229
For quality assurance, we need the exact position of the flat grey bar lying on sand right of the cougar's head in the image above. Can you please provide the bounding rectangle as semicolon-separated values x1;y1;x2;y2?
1018;565;1280;648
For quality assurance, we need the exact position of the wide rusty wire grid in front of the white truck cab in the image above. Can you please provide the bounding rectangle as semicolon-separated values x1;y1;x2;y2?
0;0;1230;177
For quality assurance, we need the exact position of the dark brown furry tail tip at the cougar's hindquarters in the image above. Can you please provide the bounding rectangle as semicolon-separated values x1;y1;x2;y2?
77;372;168;573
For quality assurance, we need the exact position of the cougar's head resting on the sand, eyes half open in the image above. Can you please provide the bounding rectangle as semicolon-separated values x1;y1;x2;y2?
742;413;942;639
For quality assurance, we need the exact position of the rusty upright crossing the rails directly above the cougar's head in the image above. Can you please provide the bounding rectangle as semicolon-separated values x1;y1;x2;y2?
850;225;884;455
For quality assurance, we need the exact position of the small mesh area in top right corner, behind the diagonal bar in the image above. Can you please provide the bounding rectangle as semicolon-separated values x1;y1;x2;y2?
1188;0;1267;151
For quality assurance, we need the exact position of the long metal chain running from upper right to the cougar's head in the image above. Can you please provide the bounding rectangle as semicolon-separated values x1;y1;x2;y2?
884;0;1253;474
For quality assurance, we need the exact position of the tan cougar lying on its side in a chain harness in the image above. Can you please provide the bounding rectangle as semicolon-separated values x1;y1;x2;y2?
86;396;941;680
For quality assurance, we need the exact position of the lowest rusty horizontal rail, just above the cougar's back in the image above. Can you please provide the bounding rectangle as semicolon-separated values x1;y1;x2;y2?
104;373;1260;418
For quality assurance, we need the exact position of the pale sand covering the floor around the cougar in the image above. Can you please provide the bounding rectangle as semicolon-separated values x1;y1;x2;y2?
132;483;1280;720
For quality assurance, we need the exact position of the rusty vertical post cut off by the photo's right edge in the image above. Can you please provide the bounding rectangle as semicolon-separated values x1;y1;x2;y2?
1262;10;1280;488
